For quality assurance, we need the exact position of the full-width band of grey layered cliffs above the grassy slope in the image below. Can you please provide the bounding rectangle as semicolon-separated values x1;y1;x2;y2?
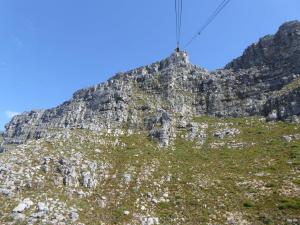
3;21;300;146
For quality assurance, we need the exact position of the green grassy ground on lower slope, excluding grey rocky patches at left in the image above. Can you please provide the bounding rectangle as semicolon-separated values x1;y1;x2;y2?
0;117;300;225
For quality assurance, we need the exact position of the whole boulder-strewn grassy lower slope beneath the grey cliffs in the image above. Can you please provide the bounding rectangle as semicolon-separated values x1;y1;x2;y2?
0;117;300;225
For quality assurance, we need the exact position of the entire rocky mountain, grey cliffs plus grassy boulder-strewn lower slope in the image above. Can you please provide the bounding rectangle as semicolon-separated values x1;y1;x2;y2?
0;21;300;225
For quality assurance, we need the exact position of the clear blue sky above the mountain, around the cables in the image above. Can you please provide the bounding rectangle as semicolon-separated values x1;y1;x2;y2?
0;0;300;130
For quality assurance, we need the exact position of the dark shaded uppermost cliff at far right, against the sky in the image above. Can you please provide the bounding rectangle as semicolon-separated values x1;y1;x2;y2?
226;21;300;74
